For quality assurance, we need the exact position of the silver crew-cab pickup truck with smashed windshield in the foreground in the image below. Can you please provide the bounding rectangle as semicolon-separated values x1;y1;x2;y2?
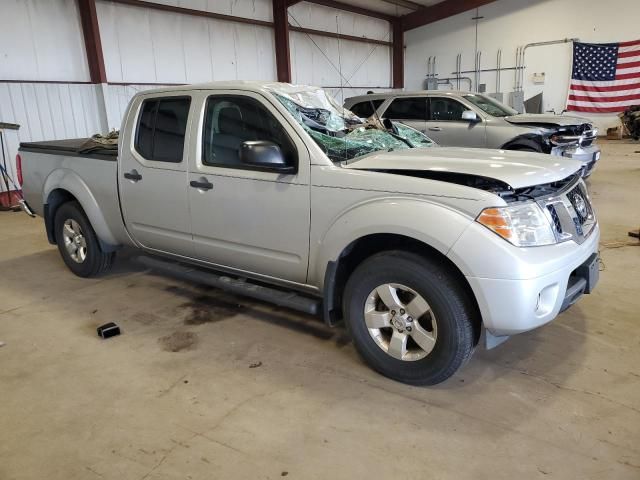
20;82;599;384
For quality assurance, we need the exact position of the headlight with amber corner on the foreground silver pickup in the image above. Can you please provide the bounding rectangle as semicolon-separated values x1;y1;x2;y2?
476;203;556;247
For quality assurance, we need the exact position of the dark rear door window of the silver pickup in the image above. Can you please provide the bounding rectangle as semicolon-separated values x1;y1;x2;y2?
135;97;191;163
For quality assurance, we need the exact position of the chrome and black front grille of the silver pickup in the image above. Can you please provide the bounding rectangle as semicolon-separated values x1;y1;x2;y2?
538;180;596;243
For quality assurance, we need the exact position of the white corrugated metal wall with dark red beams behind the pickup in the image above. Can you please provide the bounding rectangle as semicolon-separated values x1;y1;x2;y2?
0;0;391;193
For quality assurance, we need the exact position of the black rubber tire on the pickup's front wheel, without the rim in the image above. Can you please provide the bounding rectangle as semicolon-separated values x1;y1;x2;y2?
343;251;478;385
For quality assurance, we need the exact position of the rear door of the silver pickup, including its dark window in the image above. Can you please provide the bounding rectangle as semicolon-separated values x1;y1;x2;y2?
118;93;193;256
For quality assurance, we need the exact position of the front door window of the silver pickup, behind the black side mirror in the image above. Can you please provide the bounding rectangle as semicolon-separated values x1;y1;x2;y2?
202;95;296;168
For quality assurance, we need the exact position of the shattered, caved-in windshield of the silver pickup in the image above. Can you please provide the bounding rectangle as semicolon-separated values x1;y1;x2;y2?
268;85;435;162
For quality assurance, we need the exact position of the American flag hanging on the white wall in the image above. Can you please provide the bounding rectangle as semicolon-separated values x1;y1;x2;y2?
567;40;640;113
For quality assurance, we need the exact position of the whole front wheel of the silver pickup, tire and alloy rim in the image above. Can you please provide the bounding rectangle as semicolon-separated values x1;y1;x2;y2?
343;252;477;385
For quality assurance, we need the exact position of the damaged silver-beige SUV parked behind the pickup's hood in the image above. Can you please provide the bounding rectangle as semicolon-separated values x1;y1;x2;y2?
344;90;600;177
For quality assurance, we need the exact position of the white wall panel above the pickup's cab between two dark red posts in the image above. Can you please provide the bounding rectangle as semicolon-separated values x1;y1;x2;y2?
97;1;275;83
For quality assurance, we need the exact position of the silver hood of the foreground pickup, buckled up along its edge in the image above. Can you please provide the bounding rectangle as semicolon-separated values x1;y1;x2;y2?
342;147;581;189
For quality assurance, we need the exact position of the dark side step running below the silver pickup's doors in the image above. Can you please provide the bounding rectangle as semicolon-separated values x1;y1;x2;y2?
136;256;322;315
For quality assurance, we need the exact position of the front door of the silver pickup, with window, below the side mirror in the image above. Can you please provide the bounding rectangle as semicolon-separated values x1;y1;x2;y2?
189;91;310;283
